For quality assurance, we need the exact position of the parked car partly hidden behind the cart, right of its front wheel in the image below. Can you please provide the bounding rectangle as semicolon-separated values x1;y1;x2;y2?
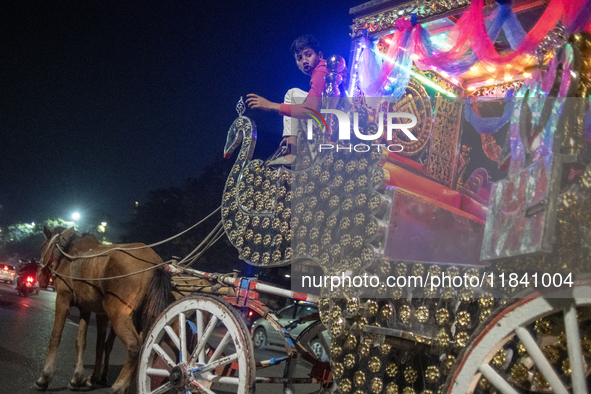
250;301;330;358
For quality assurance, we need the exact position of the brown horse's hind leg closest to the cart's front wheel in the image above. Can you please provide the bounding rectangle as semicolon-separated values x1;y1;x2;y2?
103;304;141;394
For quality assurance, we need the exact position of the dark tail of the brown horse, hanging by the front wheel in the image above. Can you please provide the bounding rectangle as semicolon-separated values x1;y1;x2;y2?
136;268;174;338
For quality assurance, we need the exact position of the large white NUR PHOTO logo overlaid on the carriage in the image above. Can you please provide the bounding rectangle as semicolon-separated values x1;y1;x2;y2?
306;108;417;152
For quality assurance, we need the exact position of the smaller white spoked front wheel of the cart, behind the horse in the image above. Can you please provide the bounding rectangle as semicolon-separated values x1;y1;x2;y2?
138;294;256;394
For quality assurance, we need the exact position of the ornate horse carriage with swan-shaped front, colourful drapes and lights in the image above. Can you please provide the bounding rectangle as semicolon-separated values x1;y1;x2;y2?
138;0;591;394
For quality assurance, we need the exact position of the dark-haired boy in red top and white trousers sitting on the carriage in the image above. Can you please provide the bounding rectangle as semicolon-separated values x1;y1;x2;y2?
246;34;328;165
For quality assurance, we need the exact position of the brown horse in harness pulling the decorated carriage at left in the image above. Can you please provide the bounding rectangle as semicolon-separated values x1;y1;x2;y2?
35;228;173;393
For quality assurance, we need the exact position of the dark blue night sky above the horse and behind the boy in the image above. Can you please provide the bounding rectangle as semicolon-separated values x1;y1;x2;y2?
0;0;364;225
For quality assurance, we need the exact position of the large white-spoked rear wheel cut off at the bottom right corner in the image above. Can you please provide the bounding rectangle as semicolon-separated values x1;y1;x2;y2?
445;281;591;394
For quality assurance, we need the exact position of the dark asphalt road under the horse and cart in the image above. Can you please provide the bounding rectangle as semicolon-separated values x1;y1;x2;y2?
0;283;320;394
